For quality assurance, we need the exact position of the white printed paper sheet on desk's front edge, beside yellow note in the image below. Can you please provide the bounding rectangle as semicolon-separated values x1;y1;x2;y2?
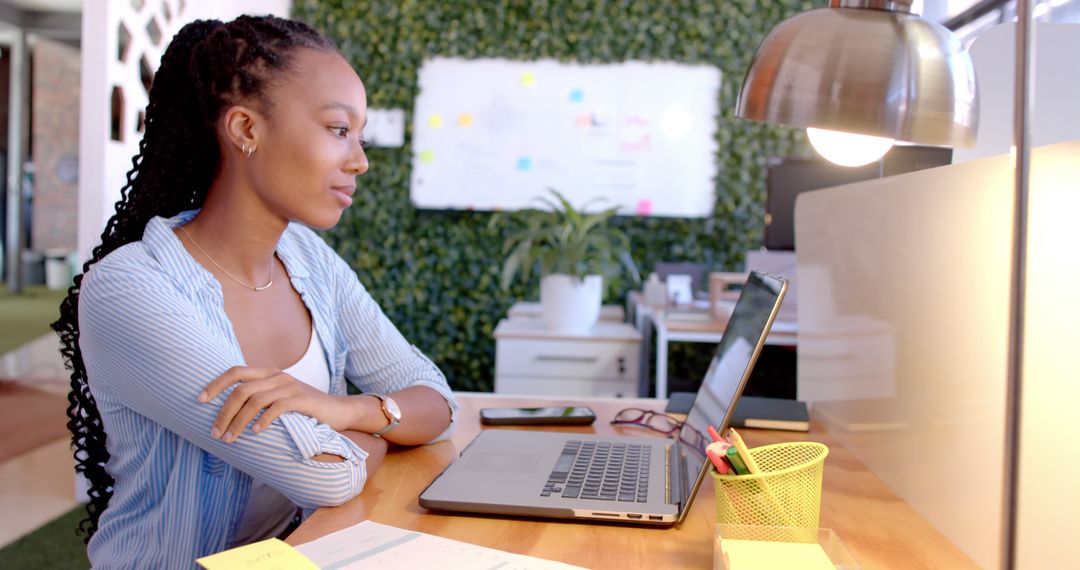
296;520;580;570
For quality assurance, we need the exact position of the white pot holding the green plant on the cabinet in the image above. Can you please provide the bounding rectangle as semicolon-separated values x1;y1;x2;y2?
540;273;604;334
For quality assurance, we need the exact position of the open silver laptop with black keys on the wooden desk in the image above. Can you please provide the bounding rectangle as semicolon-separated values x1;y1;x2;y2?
420;272;787;526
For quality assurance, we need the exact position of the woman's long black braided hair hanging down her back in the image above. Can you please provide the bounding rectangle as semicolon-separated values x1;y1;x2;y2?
52;16;335;542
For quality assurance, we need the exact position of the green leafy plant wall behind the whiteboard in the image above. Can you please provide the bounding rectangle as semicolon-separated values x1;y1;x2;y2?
293;0;815;391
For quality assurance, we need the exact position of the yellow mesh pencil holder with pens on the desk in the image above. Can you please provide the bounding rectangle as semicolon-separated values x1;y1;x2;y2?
708;442;828;529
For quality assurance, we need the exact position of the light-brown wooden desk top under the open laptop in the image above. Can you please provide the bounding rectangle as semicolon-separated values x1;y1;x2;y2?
287;393;977;570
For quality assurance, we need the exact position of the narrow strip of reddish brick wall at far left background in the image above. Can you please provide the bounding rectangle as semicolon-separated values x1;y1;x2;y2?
30;39;80;252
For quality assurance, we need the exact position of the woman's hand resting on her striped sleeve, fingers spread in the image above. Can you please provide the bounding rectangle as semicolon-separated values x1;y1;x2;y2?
199;366;350;444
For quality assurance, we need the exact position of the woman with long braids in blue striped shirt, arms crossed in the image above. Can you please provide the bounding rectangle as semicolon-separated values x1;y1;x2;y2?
53;16;457;568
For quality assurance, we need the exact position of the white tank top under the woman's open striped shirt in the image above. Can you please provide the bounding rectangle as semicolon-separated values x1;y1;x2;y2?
232;323;330;546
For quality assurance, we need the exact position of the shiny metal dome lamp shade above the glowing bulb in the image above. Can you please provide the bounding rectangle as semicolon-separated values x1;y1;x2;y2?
735;0;978;147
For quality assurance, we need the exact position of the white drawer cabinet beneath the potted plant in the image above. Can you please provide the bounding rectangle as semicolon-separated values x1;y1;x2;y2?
495;318;642;397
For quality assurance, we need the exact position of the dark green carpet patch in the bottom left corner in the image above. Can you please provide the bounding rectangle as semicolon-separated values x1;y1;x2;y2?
0;505;90;570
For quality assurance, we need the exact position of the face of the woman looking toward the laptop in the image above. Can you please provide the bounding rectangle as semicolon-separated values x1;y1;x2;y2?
244;50;368;229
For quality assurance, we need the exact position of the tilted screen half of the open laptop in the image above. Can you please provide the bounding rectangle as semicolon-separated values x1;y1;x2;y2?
678;271;787;504
